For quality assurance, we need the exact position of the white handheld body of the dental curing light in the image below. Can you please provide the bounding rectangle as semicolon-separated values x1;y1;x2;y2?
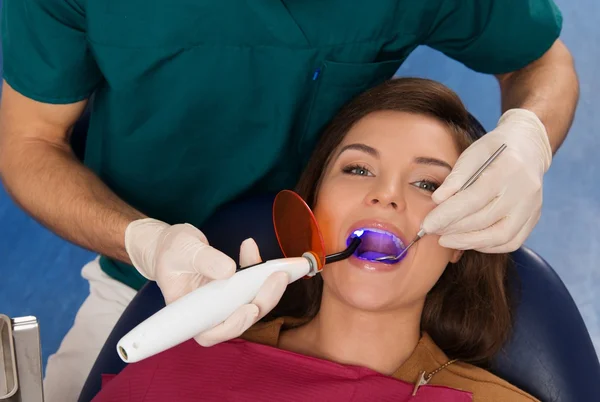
117;253;318;363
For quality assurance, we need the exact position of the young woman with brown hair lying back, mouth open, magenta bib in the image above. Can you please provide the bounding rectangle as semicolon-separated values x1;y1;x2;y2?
96;78;535;402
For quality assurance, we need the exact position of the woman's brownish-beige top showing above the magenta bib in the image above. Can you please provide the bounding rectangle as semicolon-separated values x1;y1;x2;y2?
242;318;539;402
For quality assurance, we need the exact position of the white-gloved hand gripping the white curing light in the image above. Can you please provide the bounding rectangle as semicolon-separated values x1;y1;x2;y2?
125;218;289;346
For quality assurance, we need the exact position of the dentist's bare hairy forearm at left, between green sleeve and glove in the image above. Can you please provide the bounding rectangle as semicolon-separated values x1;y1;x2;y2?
0;82;144;263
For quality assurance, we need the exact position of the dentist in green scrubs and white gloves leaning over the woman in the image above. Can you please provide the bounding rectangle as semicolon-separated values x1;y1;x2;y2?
0;0;578;402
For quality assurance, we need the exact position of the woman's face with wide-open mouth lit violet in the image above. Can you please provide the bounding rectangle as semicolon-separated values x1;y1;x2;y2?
314;111;461;311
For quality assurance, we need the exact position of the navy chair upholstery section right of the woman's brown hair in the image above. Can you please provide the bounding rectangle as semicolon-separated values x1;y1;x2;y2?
492;247;600;402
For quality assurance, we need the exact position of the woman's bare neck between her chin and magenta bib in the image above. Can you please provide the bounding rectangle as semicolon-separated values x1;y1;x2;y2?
279;291;422;375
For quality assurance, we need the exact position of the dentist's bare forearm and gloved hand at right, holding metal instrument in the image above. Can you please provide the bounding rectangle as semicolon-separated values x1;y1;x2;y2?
423;40;579;253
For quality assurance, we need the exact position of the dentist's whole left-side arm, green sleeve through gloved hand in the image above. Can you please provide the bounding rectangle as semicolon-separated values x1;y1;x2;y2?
0;0;287;343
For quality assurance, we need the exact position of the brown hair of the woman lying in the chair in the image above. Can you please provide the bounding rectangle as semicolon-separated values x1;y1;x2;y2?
269;78;512;367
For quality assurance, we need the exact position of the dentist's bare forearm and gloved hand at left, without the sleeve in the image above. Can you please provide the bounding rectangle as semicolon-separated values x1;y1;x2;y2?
0;83;288;346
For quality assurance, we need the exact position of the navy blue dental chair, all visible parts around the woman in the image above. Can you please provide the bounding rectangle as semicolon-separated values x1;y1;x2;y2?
79;196;600;402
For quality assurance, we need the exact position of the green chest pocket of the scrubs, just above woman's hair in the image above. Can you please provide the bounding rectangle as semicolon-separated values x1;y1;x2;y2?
298;58;404;159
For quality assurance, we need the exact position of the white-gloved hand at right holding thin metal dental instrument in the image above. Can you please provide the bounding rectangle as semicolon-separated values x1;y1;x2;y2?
422;109;552;253
